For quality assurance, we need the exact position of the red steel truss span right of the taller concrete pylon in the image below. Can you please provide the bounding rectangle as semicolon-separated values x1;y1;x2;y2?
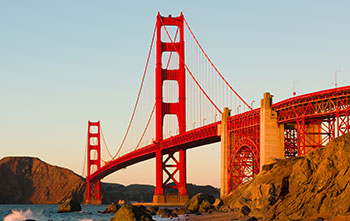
272;86;350;156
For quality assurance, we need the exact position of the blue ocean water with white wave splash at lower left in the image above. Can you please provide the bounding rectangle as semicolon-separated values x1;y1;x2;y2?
0;204;170;221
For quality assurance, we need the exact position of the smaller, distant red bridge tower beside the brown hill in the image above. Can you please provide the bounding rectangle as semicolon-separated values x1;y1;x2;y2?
86;121;101;204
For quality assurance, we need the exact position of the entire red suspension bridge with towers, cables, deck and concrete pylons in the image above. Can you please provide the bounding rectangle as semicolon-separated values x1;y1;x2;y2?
86;13;350;203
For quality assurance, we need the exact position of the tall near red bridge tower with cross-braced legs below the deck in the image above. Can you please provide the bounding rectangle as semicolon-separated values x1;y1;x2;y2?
153;13;188;203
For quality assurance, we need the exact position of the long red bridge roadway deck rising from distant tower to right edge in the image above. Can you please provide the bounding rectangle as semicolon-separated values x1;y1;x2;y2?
87;86;350;182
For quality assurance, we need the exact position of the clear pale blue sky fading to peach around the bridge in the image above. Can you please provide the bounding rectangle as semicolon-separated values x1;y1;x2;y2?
0;0;350;187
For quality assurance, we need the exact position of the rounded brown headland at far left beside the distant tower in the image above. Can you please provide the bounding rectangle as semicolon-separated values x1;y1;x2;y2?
0;157;86;204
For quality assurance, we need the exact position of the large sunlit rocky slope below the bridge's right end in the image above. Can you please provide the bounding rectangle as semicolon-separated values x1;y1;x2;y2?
224;133;350;220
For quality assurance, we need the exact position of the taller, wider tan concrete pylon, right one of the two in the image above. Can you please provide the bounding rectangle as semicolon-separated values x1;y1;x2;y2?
260;93;284;170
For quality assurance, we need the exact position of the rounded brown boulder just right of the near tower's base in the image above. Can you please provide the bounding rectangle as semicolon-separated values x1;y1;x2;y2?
185;193;215;213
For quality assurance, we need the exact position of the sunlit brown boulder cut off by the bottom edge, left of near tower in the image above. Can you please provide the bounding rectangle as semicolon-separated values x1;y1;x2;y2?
111;205;153;221
